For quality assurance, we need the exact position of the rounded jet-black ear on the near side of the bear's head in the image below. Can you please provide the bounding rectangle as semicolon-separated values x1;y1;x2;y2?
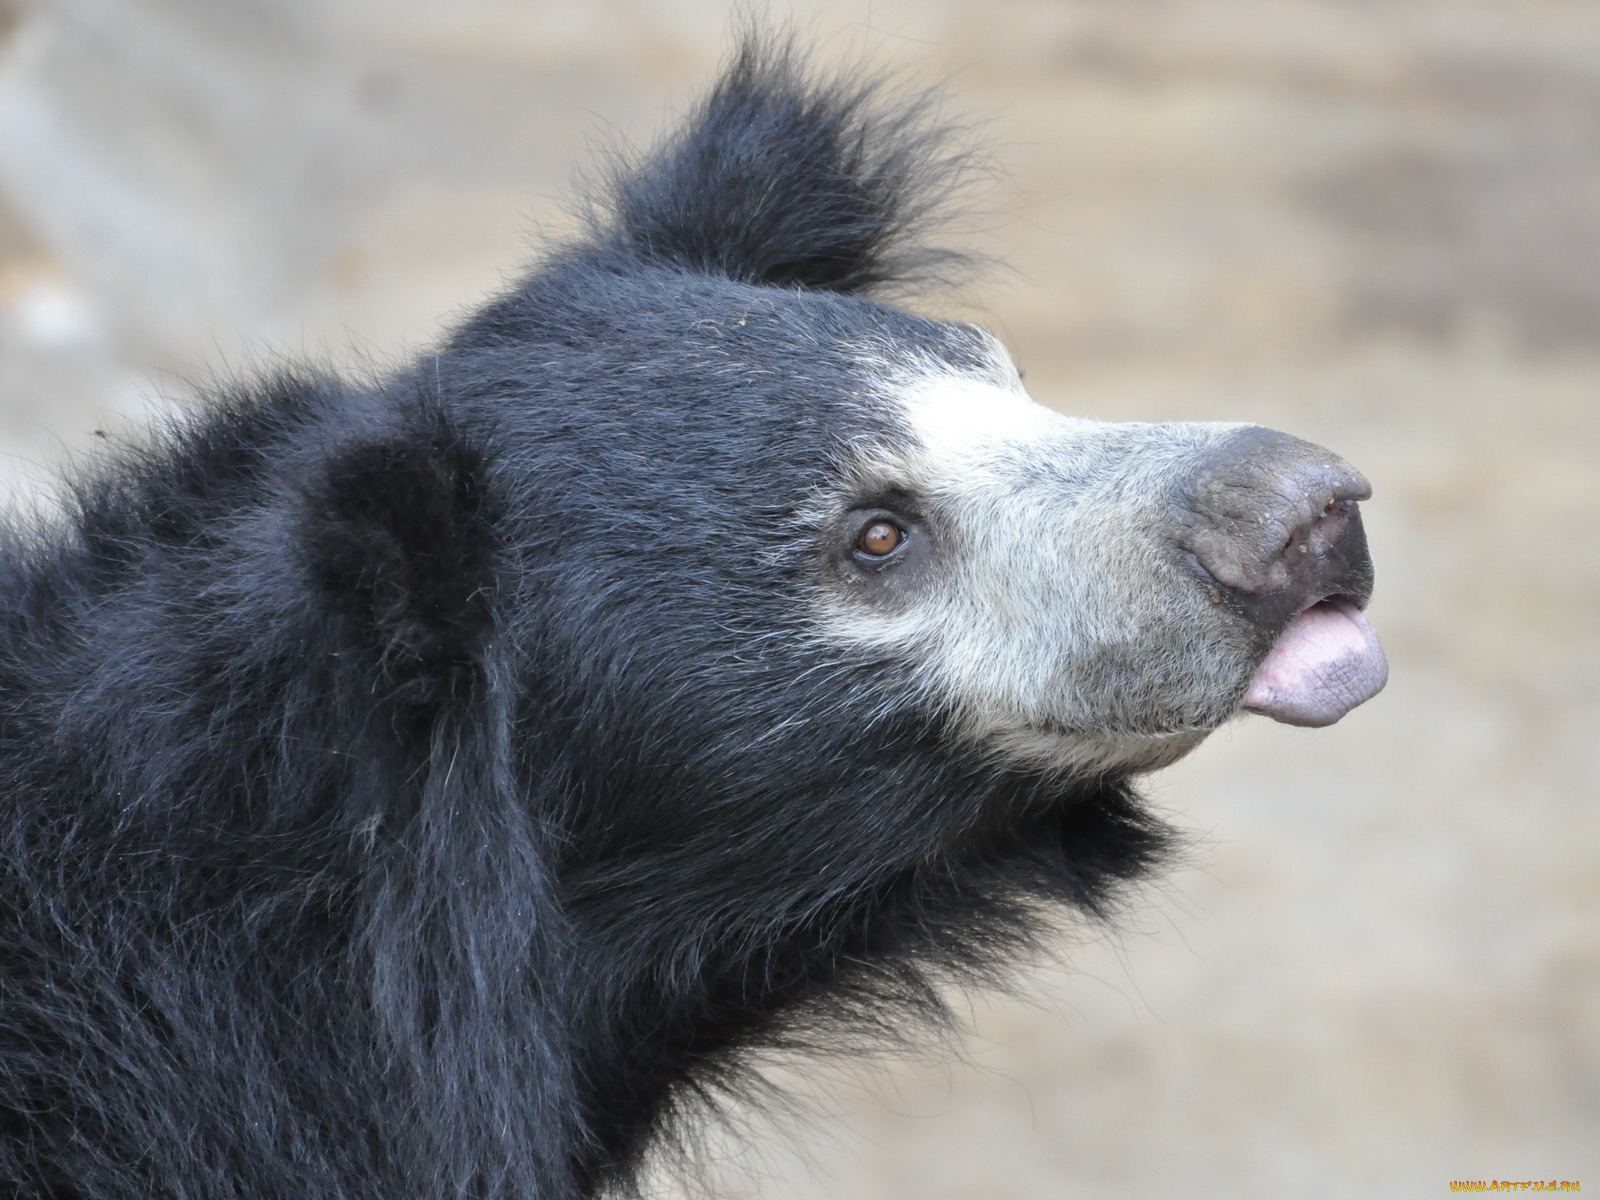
304;422;496;682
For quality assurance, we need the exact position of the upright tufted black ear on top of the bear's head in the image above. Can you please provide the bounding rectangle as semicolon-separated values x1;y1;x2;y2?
592;32;976;293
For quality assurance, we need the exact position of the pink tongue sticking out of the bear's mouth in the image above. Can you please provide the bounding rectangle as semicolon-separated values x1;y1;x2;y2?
1245;600;1389;725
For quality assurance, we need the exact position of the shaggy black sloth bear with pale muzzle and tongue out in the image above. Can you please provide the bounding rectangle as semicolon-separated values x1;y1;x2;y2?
0;38;1386;1200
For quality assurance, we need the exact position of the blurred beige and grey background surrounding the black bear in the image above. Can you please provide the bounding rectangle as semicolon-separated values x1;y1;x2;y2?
0;0;1600;1200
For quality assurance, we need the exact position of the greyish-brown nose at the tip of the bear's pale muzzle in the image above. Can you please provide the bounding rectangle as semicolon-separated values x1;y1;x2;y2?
1181;426;1373;634
